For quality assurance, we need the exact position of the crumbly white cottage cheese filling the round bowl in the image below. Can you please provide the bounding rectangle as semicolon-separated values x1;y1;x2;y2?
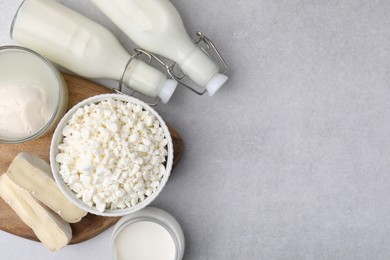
56;99;168;212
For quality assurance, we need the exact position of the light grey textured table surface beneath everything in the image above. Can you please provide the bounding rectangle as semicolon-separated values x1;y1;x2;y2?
0;0;390;260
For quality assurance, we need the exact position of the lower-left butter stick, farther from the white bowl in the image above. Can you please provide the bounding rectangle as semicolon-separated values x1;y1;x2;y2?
0;174;72;251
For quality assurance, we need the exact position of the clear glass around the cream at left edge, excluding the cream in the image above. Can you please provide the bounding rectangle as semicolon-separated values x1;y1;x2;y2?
0;45;68;144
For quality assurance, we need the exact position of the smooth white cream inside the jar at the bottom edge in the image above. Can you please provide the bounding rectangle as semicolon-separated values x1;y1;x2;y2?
115;221;176;260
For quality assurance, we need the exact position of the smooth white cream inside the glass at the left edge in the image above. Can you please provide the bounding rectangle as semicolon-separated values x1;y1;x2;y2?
0;81;53;139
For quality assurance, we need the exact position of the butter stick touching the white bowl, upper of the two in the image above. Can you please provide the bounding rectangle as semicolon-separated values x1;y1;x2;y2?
7;152;87;223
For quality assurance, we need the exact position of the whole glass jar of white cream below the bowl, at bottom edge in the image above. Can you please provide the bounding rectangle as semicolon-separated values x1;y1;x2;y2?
111;207;185;260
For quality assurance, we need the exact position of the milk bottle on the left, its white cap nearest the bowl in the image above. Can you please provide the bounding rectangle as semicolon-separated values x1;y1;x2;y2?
11;0;177;103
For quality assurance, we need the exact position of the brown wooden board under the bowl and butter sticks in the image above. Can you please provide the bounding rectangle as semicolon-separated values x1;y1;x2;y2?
0;74;184;244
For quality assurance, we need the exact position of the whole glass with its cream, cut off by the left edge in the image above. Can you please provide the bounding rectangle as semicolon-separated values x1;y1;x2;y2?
0;46;68;144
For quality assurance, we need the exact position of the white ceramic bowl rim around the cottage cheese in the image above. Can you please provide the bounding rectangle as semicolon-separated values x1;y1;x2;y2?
50;94;173;217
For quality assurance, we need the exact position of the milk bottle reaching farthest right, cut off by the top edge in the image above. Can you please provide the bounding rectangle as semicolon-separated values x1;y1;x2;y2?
90;0;228;95
